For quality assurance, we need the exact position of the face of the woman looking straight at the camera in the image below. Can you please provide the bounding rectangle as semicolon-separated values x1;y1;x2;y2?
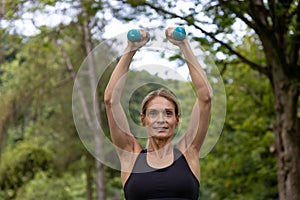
141;97;179;139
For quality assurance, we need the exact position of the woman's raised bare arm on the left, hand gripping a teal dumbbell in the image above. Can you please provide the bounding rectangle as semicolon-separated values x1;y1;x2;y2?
104;30;147;153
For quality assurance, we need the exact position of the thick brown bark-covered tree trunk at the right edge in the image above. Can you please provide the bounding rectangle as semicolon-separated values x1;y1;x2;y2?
258;14;300;197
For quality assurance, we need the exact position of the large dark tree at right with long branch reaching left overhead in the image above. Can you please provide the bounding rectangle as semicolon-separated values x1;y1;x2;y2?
111;0;300;200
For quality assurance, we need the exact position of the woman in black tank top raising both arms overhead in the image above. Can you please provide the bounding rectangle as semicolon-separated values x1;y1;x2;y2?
104;27;212;200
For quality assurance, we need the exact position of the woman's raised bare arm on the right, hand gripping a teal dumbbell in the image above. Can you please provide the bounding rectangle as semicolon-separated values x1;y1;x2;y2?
166;28;213;153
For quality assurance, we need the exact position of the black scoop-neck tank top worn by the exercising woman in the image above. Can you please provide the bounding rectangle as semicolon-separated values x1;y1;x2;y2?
124;148;200;200
